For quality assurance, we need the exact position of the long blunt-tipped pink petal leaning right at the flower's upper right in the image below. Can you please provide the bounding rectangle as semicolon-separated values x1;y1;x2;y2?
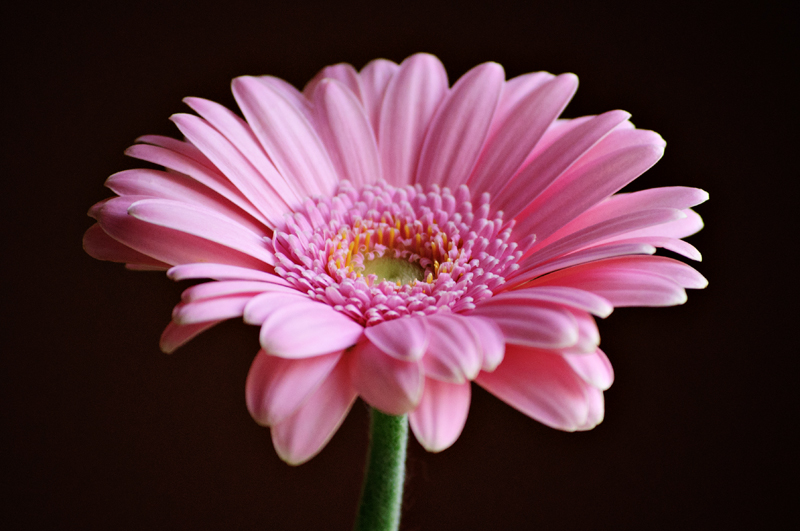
468;74;578;197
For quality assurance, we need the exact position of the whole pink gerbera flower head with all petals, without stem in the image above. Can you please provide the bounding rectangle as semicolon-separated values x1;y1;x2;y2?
84;54;707;464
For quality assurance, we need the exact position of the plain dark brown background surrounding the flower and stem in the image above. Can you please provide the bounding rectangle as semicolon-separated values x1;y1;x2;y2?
0;0;797;530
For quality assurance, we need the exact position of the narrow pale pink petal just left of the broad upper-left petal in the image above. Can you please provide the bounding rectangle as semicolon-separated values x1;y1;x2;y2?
183;98;302;207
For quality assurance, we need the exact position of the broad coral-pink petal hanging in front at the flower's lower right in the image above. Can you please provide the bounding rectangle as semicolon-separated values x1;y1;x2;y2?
475;345;589;431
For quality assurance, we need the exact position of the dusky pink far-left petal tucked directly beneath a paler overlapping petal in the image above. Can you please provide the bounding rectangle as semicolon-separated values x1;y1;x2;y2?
98;196;270;269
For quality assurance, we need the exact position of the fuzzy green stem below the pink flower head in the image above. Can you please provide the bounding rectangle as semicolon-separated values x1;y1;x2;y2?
355;409;408;531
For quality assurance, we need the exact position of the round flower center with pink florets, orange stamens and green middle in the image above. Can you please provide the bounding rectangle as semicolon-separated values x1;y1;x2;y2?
267;182;522;326
